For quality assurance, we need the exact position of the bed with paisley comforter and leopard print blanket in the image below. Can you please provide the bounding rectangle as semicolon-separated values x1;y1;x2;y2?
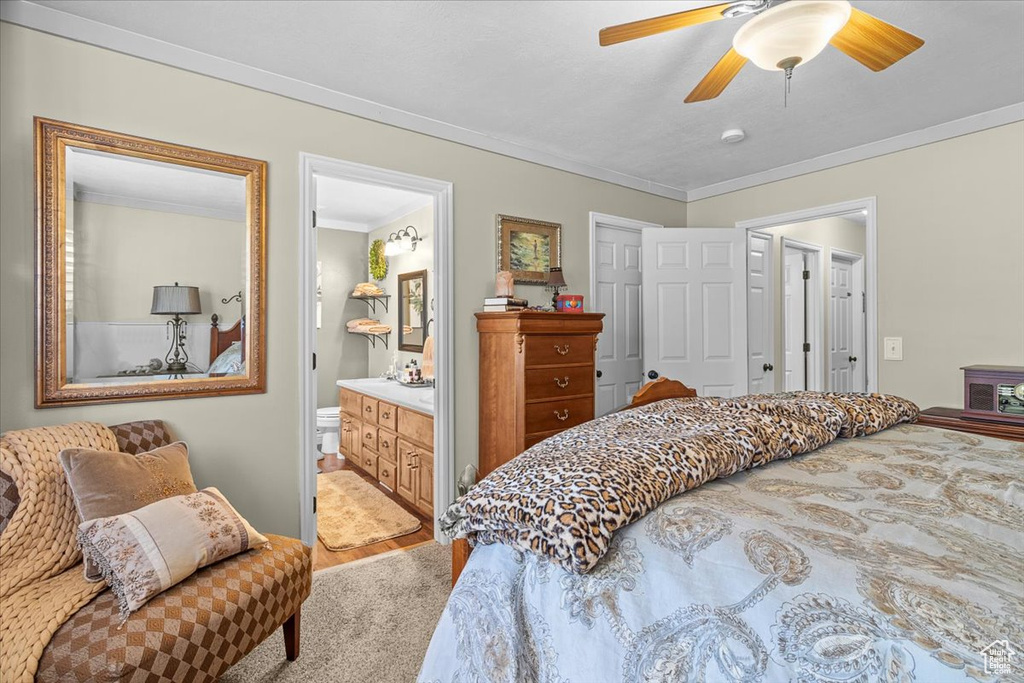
419;382;1024;683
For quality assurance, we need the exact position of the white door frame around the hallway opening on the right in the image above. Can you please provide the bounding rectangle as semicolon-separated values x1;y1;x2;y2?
736;197;879;391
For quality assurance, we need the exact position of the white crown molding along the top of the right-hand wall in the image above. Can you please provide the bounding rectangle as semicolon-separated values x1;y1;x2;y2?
686;102;1024;202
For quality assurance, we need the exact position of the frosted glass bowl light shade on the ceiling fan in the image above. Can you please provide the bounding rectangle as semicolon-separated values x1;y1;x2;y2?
732;0;851;71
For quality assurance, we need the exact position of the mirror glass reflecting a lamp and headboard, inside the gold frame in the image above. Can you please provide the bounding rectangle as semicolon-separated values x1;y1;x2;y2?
63;145;249;384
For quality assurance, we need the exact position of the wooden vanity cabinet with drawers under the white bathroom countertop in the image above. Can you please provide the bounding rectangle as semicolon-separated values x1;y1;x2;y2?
338;388;434;518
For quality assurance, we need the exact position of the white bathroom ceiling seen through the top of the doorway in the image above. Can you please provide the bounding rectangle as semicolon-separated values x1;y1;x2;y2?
316;176;433;232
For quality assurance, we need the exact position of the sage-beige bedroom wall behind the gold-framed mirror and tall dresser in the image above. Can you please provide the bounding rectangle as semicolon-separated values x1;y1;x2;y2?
0;24;688;535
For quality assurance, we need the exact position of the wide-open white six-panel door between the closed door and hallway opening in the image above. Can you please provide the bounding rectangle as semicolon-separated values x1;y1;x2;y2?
641;227;746;396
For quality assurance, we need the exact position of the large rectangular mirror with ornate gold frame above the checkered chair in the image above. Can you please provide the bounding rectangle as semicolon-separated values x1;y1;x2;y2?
35;117;266;408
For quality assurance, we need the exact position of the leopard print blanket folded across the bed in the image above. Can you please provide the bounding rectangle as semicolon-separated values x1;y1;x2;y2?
440;392;919;573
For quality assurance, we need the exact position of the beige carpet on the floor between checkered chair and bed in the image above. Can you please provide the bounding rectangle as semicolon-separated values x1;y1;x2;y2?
221;543;452;683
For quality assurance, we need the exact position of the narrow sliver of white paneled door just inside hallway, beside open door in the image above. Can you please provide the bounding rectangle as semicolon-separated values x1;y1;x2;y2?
746;230;775;393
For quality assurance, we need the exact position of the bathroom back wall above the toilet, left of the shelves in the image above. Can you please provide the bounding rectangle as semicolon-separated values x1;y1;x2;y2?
316;227;369;408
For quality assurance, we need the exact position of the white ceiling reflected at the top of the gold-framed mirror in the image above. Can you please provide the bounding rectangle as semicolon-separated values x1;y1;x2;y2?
66;147;246;222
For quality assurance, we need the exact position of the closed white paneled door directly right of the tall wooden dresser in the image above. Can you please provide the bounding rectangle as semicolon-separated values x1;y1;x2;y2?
594;223;638;416
